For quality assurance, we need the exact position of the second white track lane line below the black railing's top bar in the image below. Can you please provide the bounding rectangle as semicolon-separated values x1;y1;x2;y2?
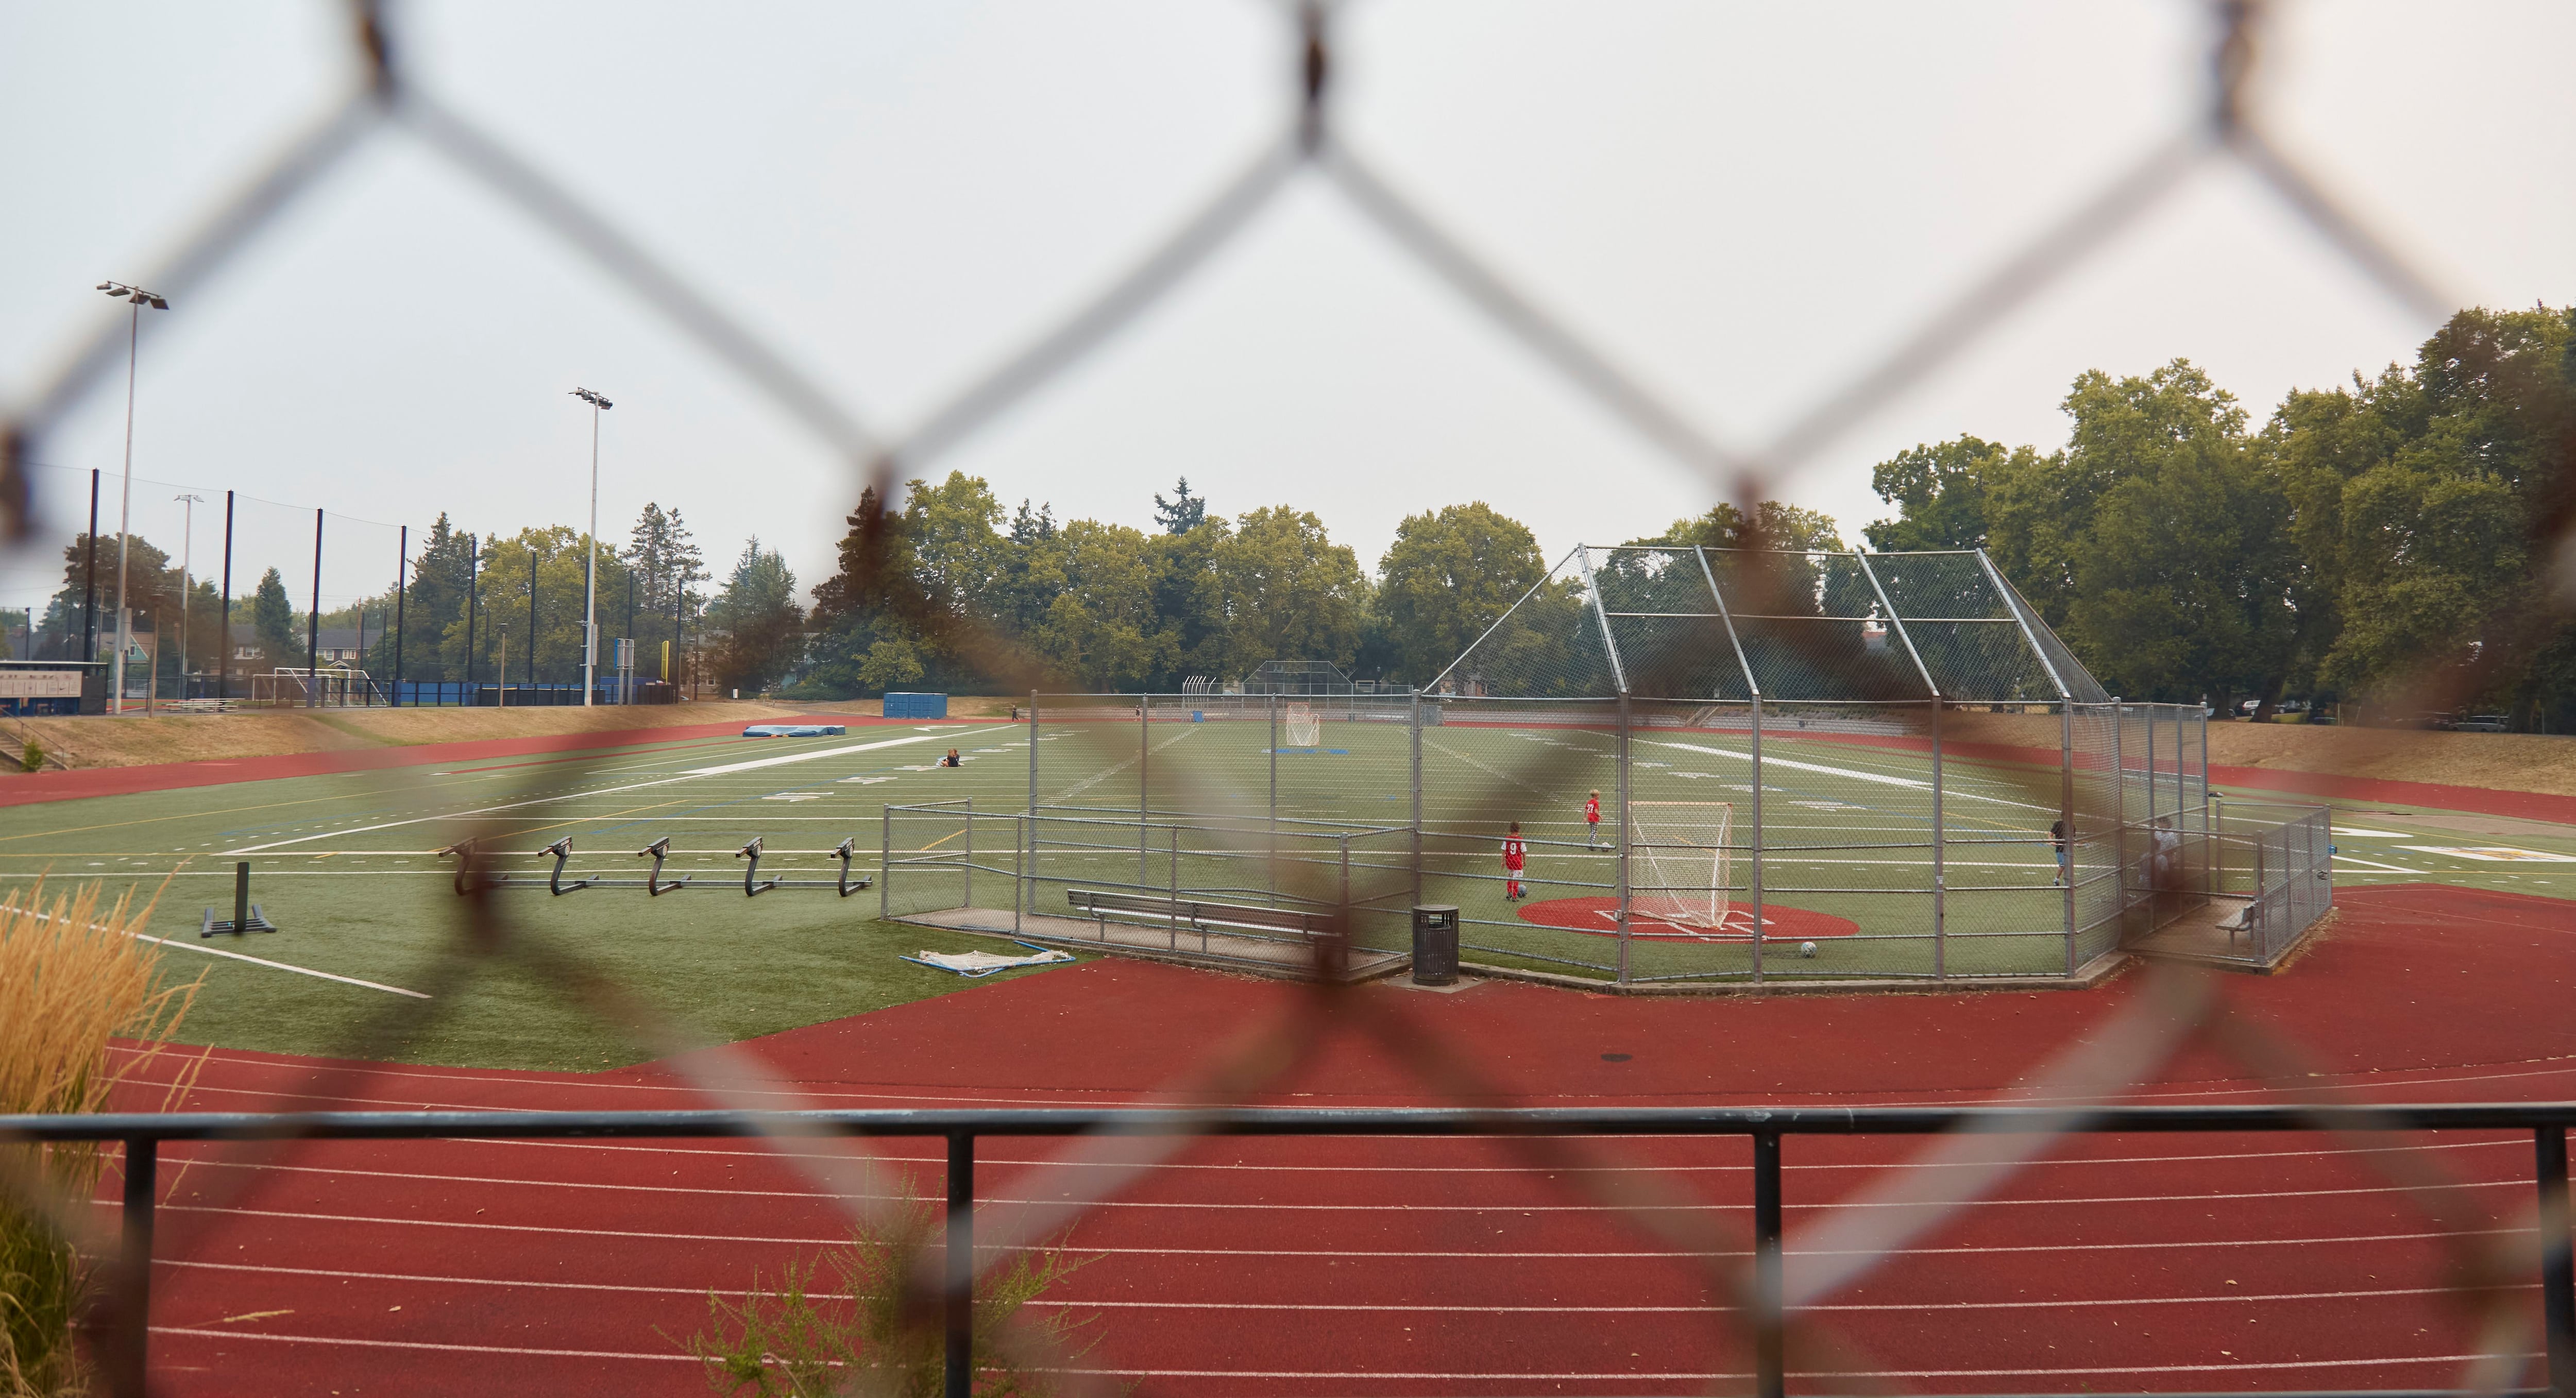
135;1202;2530;1261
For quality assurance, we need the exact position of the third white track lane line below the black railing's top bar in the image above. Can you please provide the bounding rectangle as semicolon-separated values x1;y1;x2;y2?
155;1259;2504;1316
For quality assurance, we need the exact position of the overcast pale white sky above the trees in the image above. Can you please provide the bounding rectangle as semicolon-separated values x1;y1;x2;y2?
0;0;2576;618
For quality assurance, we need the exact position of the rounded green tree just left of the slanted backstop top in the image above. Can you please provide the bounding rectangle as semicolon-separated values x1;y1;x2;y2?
1373;500;1548;683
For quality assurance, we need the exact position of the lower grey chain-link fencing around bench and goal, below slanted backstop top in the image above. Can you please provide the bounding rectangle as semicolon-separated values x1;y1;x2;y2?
878;693;2331;986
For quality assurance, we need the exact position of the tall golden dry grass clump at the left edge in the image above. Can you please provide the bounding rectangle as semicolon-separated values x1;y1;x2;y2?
0;883;198;1398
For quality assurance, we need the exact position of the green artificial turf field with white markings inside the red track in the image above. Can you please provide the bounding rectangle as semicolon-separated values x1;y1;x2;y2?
0;710;2576;1068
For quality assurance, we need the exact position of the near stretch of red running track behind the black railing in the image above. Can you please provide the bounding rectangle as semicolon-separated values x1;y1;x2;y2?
111;885;2576;1395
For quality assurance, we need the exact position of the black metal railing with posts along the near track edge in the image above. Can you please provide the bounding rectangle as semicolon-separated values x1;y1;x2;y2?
0;1102;2576;1398
